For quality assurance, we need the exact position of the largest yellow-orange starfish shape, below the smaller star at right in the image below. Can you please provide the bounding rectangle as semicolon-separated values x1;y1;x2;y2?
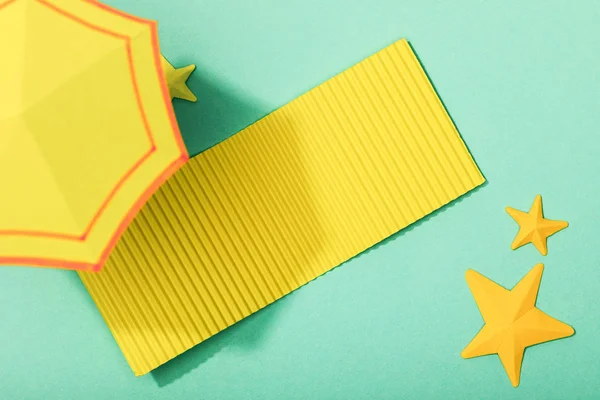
461;264;575;387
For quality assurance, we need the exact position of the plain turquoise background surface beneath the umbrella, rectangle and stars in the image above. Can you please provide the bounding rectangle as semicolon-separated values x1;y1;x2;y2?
0;0;600;400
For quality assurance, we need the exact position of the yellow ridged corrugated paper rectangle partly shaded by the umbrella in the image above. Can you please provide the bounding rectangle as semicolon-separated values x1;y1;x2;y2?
80;40;484;375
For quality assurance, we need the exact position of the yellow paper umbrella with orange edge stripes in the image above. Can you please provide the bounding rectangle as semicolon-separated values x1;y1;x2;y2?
0;0;188;270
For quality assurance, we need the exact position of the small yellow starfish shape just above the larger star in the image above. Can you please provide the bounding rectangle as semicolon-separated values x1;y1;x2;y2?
506;194;569;256
